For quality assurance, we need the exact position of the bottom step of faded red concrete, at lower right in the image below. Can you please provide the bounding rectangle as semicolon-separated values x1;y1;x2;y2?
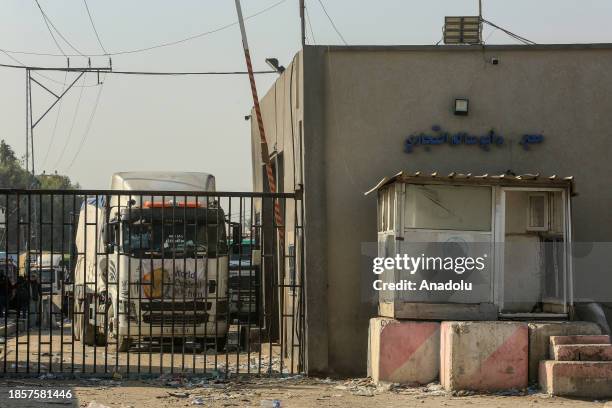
539;360;612;398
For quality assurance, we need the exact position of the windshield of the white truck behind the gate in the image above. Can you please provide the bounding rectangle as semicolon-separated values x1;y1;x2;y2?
122;209;227;257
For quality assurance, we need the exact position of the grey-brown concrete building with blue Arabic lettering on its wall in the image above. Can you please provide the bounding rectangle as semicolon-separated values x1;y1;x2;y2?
252;44;612;374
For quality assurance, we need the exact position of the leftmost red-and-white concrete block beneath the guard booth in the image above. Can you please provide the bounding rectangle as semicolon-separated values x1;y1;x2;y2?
368;317;440;384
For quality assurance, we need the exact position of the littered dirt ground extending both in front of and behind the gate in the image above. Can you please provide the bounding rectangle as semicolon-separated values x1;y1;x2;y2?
0;327;612;408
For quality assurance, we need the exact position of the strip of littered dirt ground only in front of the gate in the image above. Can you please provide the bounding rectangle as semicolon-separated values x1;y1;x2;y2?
0;376;612;408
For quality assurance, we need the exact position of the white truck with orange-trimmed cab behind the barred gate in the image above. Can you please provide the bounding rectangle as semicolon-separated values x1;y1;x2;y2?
73;172;229;351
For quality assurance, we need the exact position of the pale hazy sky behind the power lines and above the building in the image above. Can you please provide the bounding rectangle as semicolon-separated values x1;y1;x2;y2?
0;0;612;191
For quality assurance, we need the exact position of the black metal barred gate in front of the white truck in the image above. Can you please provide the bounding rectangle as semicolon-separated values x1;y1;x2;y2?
0;190;304;376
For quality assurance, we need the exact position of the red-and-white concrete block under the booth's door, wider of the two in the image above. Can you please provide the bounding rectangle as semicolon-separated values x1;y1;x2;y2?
440;322;529;391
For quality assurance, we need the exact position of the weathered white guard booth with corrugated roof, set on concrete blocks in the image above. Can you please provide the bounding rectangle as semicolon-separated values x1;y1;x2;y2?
366;172;574;320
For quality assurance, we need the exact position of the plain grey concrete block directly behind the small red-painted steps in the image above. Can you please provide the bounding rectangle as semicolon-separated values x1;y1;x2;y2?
529;321;601;383
